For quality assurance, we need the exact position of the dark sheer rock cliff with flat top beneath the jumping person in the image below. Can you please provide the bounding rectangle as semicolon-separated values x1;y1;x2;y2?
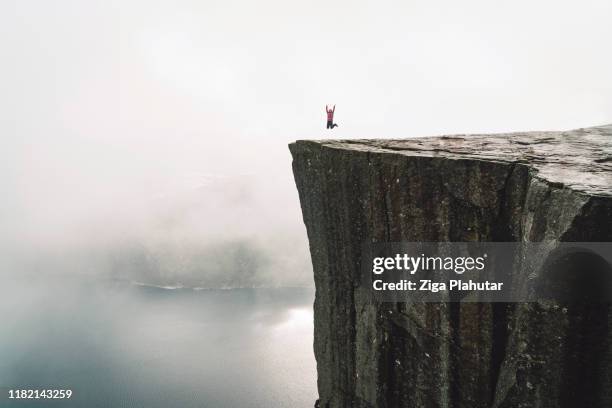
290;126;612;408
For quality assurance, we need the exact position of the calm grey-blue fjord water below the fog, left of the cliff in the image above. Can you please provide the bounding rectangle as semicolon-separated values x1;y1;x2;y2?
0;280;317;408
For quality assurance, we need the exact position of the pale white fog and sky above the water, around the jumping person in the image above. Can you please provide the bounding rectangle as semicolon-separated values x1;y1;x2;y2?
0;0;612;287
